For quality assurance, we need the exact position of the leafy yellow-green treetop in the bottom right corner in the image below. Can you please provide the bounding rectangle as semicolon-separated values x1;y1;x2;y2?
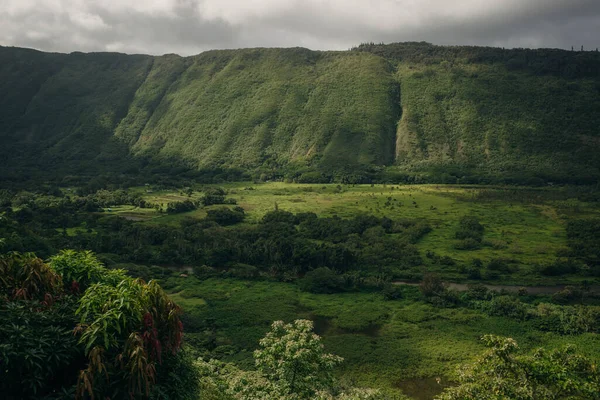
437;335;600;400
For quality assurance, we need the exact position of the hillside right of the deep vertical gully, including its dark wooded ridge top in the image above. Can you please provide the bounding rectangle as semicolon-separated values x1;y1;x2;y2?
357;43;600;181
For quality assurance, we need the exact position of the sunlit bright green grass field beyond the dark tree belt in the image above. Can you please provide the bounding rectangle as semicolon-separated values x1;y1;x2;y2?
126;182;600;285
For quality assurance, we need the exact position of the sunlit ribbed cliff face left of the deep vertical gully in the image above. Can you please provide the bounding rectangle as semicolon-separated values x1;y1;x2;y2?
116;49;397;168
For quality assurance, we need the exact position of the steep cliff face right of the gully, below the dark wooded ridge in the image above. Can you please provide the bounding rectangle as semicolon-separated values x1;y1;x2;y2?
396;64;600;180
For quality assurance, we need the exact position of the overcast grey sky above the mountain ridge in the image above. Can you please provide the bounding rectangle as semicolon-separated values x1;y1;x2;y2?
0;0;600;55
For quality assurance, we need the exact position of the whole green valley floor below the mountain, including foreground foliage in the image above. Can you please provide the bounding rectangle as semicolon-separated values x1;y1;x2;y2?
0;183;600;400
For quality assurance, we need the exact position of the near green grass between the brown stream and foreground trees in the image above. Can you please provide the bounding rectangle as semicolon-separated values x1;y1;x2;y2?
166;277;600;399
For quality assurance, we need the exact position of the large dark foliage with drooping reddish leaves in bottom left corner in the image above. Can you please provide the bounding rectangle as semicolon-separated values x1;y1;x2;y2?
0;250;188;398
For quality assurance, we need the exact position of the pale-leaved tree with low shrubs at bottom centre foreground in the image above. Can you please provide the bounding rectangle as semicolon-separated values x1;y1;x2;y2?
198;320;382;400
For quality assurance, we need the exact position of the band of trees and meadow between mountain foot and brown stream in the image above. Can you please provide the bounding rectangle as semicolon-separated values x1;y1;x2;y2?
0;184;600;291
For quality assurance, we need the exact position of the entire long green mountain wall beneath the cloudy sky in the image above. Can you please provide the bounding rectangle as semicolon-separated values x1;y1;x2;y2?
0;43;600;182
